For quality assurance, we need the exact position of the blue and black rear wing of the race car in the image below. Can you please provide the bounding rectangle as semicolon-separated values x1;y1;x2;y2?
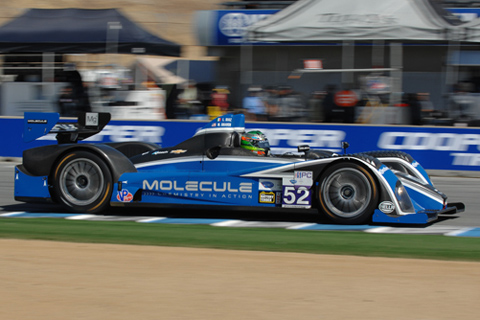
23;112;111;144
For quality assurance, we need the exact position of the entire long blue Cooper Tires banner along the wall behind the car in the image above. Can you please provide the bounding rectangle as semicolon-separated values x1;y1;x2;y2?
0;118;480;171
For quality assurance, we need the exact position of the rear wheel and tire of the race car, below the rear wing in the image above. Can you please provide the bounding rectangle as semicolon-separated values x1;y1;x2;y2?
53;151;113;213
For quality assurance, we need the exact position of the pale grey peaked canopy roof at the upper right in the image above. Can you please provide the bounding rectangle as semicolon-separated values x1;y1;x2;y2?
249;0;466;42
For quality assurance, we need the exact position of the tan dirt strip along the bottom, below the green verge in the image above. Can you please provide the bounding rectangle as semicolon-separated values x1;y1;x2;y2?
0;239;480;320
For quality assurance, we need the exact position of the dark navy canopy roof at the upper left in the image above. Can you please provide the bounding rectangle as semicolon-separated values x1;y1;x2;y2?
0;9;180;56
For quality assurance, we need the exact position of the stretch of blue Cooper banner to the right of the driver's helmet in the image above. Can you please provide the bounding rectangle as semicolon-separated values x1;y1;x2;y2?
249;123;480;171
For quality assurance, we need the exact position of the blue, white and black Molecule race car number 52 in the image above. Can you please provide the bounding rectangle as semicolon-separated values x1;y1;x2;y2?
15;113;465;224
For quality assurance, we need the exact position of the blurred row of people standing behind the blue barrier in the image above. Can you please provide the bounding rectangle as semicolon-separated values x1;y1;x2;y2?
166;81;454;125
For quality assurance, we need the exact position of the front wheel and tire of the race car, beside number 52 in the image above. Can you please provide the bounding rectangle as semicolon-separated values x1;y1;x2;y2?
317;162;379;224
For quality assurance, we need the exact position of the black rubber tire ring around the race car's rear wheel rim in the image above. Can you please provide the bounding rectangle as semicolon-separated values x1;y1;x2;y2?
52;151;113;213
